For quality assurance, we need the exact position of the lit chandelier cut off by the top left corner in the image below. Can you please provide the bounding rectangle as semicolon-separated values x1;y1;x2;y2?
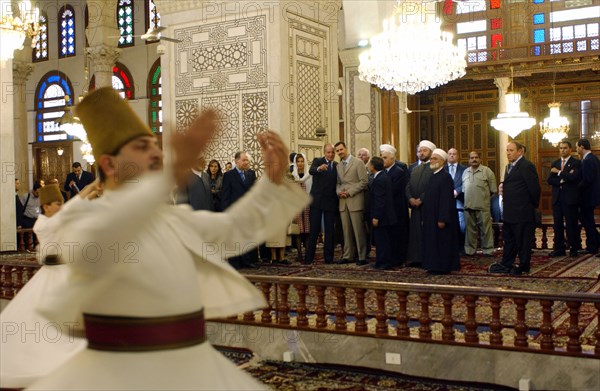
0;0;40;63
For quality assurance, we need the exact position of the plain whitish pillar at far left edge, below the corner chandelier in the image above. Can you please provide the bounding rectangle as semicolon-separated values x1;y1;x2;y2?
0;56;17;251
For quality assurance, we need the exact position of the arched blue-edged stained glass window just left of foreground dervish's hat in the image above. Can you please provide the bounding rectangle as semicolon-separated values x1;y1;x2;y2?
35;71;73;141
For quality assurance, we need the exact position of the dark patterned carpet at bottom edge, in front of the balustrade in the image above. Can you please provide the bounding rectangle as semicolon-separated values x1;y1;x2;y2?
215;346;513;391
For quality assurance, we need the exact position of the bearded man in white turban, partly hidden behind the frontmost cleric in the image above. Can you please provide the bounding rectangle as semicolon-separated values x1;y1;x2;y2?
406;140;436;266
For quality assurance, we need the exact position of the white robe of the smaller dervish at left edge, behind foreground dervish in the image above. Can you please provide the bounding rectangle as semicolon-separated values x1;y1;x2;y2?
0;208;87;388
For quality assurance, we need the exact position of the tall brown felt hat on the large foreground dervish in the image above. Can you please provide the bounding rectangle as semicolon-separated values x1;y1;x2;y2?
75;87;154;161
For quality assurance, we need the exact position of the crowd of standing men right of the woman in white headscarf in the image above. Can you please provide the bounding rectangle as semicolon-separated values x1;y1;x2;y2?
303;139;600;275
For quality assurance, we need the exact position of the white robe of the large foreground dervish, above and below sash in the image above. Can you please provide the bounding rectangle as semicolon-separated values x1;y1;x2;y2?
26;174;309;390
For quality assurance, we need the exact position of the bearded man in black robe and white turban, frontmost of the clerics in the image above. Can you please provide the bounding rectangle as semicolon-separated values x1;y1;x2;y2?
421;149;460;274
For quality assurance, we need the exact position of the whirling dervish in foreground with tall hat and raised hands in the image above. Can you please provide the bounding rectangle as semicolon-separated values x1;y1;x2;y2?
23;87;308;390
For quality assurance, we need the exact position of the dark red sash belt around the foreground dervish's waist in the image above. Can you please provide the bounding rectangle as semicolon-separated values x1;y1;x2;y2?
83;309;206;352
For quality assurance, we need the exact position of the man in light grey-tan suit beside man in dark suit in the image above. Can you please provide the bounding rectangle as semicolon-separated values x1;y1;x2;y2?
335;141;369;265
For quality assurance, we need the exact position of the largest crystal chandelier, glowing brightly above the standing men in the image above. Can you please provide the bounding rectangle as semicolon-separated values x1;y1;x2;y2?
358;0;467;94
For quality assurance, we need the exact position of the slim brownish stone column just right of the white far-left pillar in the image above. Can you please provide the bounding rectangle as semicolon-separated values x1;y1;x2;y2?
13;60;33;192
